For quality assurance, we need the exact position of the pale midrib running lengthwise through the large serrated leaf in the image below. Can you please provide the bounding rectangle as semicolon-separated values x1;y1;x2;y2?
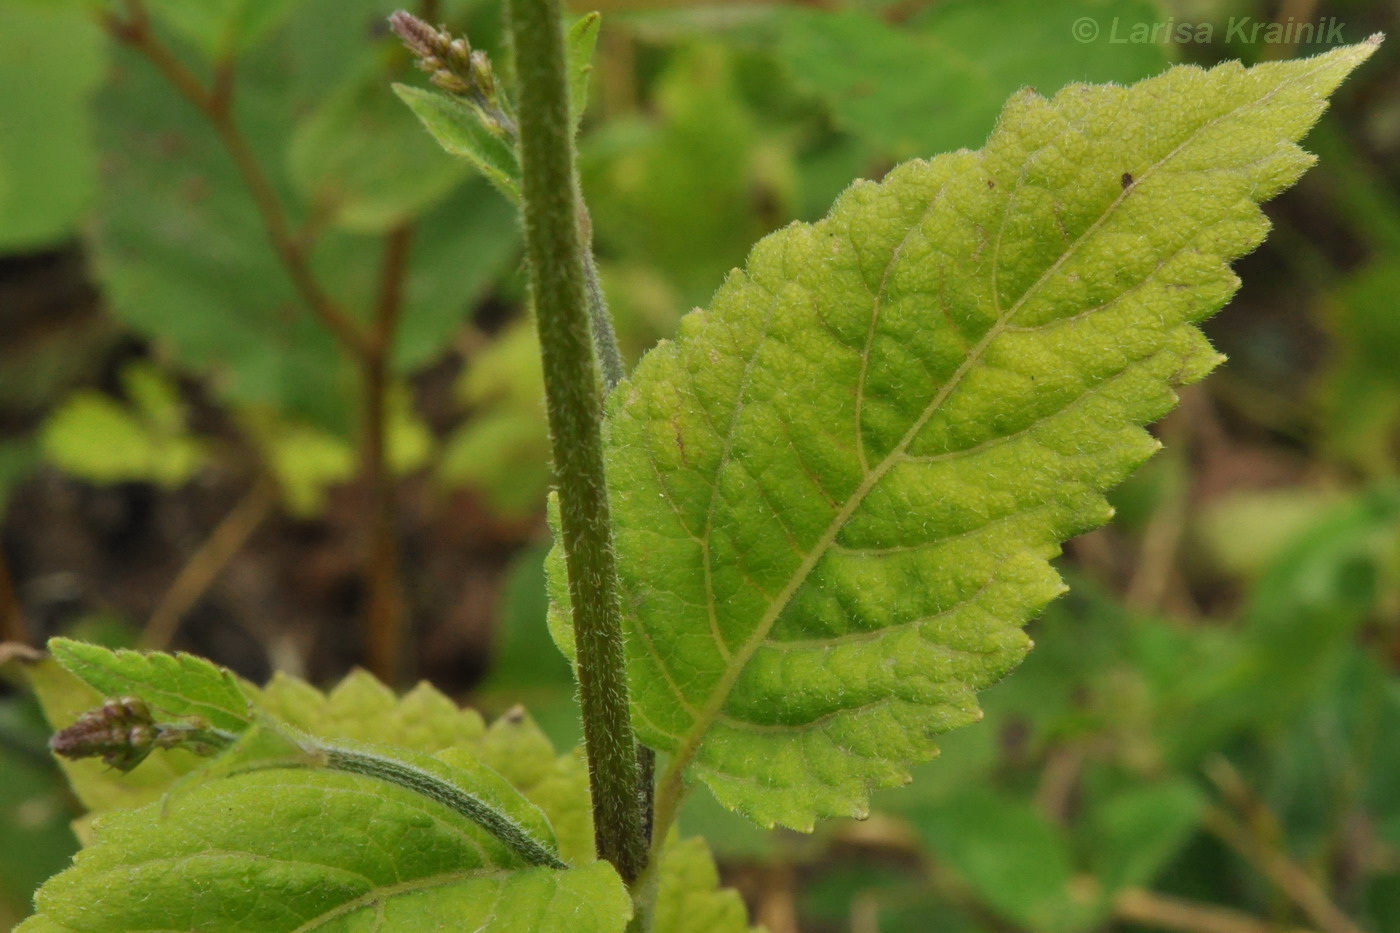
658;52;1324;803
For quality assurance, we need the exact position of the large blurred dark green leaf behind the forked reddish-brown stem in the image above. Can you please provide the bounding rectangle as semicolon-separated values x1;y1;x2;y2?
92;27;517;437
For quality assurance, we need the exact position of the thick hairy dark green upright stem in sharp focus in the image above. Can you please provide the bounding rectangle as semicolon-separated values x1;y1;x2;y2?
510;0;647;884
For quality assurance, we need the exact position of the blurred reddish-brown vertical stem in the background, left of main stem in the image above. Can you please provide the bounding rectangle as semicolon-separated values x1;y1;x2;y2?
361;226;413;684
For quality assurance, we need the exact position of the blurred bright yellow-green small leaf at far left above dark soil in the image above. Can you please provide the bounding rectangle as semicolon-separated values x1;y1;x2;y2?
39;364;209;488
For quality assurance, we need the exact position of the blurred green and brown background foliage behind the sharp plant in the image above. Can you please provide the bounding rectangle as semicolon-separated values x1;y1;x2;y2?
0;0;1400;933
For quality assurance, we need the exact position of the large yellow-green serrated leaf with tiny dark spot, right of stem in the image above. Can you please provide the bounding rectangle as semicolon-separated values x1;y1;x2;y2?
552;41;1376;829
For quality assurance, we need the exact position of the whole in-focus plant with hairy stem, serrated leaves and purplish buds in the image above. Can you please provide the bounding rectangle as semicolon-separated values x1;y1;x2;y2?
20;0;1379;933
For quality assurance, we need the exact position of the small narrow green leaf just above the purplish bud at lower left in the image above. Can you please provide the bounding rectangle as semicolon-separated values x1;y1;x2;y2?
49;639;253;733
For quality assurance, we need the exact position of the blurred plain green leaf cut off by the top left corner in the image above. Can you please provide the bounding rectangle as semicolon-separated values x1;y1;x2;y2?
0;3;106;252
